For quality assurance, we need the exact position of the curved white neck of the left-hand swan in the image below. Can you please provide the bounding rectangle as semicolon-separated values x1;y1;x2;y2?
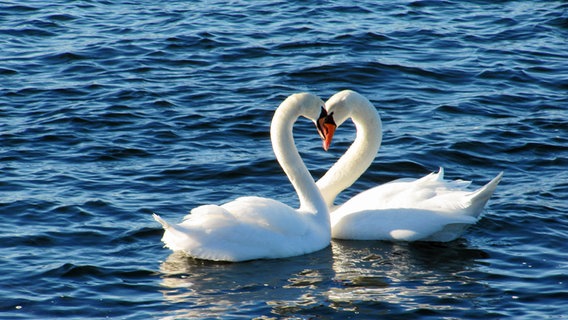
270;96;329;219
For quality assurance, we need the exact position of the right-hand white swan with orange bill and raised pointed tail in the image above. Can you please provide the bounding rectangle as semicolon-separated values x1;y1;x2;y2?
317;90;503;242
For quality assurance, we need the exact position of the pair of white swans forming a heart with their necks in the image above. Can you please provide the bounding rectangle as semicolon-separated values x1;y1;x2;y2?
154;90;502;261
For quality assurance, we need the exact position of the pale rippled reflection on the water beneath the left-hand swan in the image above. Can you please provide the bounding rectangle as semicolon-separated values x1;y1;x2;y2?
156;250;332;319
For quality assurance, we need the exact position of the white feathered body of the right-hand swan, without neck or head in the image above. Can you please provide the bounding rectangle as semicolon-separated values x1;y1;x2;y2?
331;168;502;242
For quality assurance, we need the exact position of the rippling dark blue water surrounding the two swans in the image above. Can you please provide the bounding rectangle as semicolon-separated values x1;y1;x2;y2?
0;0;568;319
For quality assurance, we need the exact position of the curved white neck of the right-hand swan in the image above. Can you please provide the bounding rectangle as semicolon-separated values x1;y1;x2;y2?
317;94;382;208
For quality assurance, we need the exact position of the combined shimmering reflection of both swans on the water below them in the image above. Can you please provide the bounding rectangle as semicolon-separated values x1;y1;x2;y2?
156;240;487;318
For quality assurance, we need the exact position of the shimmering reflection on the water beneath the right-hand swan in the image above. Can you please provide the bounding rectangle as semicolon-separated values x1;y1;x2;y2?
327;240;487;314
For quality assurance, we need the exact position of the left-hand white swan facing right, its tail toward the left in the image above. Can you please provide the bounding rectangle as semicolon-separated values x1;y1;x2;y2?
154;93;331;261
